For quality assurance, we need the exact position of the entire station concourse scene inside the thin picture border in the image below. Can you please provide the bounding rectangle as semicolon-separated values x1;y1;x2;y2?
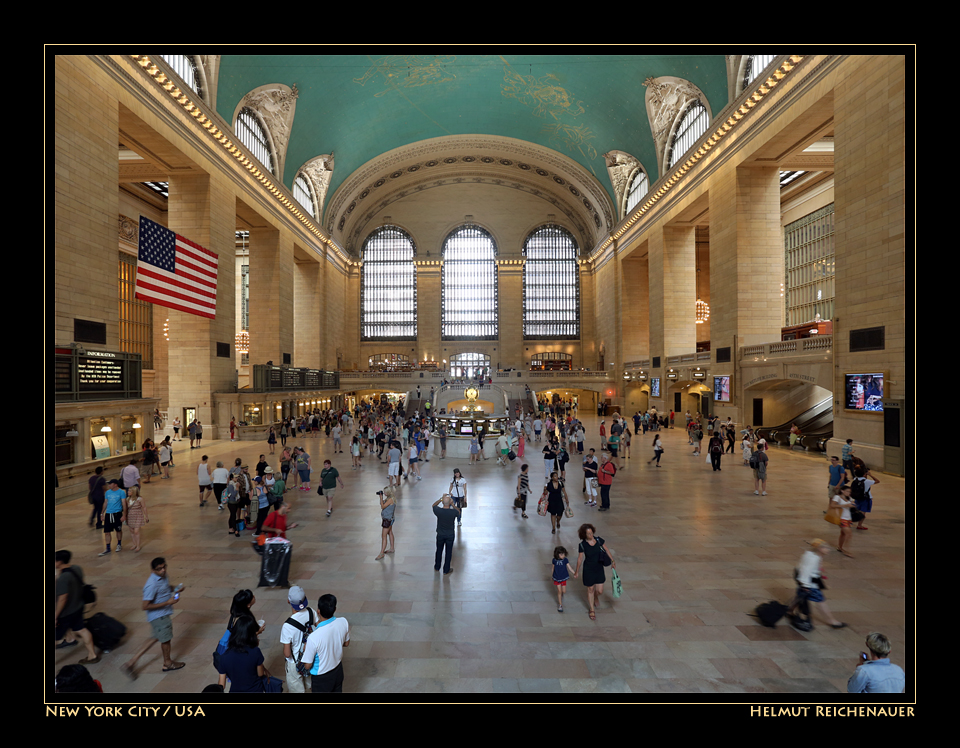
52;55;916;703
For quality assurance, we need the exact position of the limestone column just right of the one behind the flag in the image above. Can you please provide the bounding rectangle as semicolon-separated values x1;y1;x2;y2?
250;228;294;366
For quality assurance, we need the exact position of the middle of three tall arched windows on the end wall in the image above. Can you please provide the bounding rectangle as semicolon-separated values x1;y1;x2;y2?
441;225;498;340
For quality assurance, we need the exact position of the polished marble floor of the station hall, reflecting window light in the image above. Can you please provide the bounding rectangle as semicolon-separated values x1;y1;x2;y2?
48;417;914;701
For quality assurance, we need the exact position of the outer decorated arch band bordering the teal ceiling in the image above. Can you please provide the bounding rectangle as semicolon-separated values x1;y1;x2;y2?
326;136;616;243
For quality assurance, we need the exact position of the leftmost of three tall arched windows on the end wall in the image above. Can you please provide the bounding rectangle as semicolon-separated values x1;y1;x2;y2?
360;226;417;340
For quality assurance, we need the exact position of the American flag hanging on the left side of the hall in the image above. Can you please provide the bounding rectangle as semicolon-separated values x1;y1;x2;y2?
136;216;217;319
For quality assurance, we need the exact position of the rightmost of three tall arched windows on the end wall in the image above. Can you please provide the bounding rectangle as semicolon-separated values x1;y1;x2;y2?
523;225;580;340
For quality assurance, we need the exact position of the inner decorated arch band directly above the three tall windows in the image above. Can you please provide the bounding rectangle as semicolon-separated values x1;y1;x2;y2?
338;169;601;255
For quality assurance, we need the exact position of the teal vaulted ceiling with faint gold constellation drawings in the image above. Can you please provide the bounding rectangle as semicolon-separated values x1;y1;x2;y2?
217;54;727;221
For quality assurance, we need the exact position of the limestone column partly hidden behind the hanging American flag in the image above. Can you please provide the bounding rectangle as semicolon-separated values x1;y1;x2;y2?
166;174;236;439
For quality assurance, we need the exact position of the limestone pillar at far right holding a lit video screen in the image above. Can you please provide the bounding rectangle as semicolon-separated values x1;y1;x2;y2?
829;55;914;474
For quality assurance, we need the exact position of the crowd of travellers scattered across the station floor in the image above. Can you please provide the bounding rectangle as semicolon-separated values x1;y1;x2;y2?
56;394;903;693
